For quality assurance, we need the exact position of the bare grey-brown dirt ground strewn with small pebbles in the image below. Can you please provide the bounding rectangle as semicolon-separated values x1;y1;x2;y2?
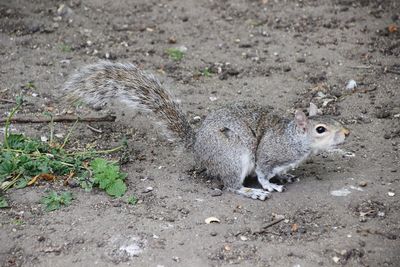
0;0;400;267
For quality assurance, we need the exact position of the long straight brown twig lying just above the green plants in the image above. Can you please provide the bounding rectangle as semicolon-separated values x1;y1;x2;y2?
0;115;116;123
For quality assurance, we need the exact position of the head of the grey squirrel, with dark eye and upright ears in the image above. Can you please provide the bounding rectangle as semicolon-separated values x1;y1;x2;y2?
294;103;350;152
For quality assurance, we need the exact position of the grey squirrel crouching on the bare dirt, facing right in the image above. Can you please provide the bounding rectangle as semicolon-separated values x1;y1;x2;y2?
64;61;350;200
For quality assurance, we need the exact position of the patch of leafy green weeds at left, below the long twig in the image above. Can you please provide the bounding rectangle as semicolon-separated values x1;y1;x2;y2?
0;98;127;201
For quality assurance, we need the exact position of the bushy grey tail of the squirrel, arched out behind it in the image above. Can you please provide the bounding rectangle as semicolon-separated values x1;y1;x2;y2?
64;61;193;143
